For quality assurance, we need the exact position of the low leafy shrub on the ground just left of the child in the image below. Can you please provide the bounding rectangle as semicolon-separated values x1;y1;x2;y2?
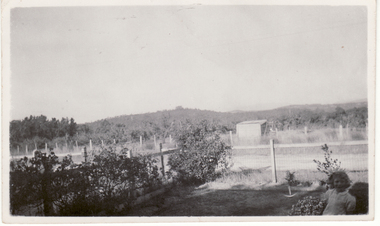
289;196;326;216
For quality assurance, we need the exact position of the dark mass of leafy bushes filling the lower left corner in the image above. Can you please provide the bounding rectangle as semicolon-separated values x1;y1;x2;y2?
10;147;161;216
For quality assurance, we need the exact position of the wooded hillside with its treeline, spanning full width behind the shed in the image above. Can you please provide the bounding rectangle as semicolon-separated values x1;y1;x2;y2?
10;102;368;148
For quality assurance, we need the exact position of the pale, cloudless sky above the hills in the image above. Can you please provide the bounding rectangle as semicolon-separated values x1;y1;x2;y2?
10;5;368;123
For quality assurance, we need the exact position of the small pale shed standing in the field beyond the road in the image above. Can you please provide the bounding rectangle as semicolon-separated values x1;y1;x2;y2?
236;120;267;140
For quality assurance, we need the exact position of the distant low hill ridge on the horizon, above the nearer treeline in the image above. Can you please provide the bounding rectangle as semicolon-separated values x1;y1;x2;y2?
86;101;367;130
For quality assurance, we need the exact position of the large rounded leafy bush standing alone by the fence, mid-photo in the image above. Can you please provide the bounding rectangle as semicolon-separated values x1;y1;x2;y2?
168;120;231;184
